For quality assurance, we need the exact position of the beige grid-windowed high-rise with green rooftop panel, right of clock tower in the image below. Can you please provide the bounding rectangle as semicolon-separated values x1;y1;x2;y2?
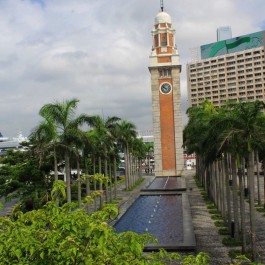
187;31;265;107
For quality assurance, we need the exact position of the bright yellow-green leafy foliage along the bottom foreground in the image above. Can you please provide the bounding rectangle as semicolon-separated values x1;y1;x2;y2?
0;198;208;265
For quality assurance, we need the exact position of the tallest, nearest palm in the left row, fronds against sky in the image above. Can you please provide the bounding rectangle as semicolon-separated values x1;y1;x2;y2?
40;98;93;202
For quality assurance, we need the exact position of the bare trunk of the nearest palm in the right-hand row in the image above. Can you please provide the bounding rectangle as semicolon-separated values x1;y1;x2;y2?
248;152;257;261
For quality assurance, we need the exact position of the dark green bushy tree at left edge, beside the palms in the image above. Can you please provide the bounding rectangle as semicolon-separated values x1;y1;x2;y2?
0;151;52;210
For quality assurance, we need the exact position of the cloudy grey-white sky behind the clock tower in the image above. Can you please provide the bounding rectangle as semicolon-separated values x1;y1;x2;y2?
0;0;265;137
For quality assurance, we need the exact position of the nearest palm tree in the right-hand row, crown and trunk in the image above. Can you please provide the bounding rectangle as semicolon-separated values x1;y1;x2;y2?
213;101;265;260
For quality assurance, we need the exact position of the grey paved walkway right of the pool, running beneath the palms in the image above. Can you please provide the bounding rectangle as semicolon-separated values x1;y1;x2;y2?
185;171;265;265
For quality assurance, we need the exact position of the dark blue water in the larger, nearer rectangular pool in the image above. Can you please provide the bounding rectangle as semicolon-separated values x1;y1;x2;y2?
114;194;183;244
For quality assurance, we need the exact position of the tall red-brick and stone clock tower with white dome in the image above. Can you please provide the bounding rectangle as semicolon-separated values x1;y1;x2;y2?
149;1;184;177
